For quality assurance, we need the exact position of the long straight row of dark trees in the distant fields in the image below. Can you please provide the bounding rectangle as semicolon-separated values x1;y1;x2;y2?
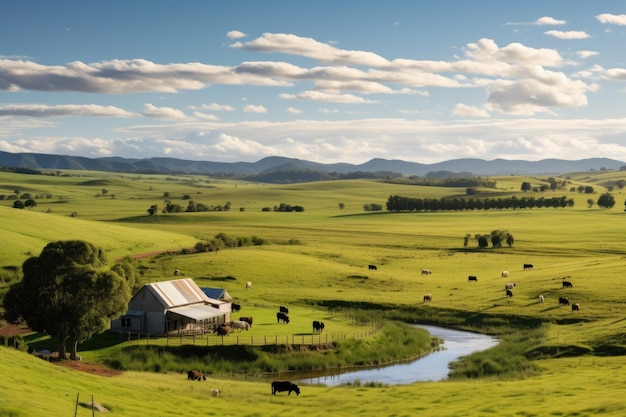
387;195;574;212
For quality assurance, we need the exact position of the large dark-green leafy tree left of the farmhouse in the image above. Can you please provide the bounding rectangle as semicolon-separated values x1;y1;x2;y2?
4;240;131;359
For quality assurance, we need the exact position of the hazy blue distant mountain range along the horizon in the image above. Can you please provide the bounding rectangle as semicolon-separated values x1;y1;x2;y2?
0;152;626;177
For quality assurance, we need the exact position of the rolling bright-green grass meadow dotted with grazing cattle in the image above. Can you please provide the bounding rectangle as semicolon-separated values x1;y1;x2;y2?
0;167;626;416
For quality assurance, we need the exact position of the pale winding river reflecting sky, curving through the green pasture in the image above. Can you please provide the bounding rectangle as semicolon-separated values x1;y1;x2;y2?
292;325;498;386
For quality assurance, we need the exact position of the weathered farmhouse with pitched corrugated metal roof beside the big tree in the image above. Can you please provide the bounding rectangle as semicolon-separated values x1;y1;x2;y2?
111;278;231;335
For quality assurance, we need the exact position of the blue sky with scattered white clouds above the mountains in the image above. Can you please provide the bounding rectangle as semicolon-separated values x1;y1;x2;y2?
0;0;626;164
